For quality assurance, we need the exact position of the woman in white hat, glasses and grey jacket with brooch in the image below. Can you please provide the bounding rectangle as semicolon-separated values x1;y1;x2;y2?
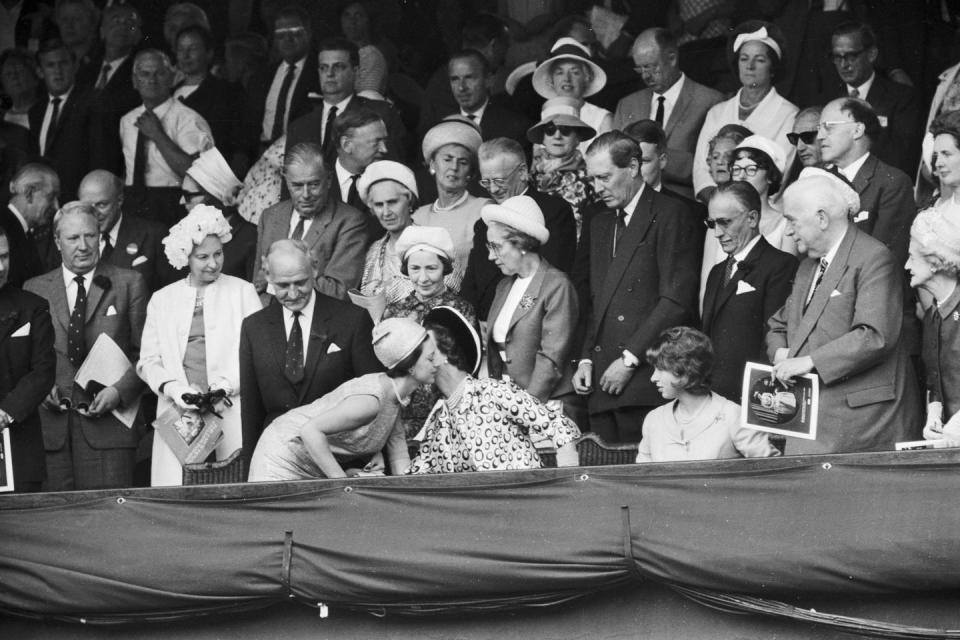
481;196;580;402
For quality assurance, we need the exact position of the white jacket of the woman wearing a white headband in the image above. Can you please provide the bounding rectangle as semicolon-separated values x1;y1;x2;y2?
693;89;798;195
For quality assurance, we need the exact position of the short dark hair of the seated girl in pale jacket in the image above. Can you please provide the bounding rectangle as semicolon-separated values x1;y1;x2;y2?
647;327;713;395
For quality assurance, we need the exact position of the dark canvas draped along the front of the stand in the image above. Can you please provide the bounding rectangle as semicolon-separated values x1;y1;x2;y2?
0;452;960;619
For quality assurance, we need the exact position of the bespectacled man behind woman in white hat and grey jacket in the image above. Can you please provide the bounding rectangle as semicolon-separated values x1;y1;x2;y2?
460;138;577;321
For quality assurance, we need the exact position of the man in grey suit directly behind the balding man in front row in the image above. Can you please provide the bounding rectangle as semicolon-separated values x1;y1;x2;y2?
253;142;367;304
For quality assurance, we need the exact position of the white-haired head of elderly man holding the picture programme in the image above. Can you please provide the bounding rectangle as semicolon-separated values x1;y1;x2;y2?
783;176;859;258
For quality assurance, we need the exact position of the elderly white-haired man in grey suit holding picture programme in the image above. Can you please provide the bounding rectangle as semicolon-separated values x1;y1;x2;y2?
767;169;923;454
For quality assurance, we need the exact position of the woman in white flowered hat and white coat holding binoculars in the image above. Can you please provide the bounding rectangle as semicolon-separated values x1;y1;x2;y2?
137;205;261;486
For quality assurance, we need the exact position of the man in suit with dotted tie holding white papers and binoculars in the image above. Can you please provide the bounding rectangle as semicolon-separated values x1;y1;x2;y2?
24;202;148;491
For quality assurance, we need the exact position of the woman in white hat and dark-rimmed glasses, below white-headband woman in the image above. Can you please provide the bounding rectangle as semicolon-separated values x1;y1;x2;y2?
700;135;797;303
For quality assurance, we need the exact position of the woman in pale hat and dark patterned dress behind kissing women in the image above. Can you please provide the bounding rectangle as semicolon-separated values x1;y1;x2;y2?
383;225;476;436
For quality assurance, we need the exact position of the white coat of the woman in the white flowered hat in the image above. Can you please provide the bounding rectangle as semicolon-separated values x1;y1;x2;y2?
137;274;261;486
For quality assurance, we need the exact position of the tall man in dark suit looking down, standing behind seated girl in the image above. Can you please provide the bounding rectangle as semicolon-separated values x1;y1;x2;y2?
573;131;703;442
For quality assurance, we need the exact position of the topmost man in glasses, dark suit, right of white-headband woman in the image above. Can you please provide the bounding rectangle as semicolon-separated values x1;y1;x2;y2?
822;22;921;175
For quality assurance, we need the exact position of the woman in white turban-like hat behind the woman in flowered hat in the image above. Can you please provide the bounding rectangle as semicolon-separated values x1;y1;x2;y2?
180;147;257;280
